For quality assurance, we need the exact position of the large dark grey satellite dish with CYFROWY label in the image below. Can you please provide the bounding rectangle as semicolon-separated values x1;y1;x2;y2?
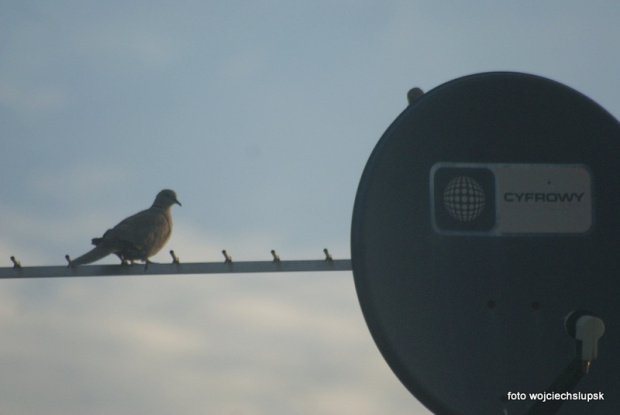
351;73;620;415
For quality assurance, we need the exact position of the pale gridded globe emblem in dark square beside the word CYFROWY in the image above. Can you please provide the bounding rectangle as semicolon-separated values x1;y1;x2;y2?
443;176;485;222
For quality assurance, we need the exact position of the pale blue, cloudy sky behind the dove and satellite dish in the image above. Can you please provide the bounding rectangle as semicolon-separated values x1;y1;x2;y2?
0;0;620;415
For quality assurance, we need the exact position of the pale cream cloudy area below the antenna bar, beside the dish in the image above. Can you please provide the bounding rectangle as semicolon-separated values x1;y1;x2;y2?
0;264;422;414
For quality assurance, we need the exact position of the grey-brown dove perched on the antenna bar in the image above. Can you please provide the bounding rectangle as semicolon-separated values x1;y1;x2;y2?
70;189;181;266
